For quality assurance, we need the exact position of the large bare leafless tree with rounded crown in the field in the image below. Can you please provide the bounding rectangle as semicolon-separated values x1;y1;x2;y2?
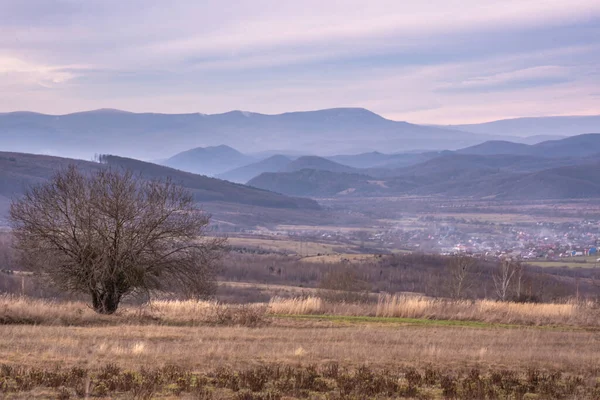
10;166;223;314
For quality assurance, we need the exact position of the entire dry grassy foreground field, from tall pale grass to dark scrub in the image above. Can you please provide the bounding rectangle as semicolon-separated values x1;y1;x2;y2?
0;297;600;399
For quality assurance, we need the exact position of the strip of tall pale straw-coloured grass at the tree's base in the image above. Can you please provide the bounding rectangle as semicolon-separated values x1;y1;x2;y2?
0;295;600;327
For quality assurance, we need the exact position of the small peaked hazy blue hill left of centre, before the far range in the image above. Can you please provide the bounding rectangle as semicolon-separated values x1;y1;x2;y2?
162;145;256;176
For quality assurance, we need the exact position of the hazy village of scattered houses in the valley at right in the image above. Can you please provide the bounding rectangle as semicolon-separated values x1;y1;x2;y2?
277;218;600;263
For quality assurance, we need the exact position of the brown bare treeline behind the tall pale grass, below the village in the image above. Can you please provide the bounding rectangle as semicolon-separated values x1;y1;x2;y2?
0;234;600;302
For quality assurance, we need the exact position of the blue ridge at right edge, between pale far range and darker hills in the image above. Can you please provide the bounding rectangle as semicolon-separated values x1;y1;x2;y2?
457;133;600;157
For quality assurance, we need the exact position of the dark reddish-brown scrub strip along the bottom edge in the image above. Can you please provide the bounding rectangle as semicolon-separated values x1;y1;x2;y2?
0;362;600;400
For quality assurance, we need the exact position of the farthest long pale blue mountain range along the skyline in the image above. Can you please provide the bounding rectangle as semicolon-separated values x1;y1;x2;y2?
0;108;488;161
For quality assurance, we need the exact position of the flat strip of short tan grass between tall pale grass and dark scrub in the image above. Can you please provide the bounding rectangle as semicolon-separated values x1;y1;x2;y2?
0;319;600;373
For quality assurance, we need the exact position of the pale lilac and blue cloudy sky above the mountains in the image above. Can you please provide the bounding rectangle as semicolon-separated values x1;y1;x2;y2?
0;0;600;124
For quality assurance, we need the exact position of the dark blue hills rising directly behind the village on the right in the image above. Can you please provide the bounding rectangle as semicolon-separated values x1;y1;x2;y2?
249;147;600;200
